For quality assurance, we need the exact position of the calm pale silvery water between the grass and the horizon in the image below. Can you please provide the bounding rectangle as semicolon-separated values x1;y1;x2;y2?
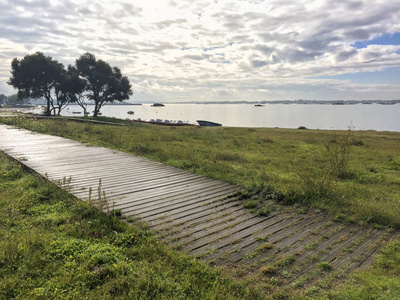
63;104;400;132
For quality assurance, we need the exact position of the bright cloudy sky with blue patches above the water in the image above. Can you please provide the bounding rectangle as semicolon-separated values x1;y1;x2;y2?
0;0;400;102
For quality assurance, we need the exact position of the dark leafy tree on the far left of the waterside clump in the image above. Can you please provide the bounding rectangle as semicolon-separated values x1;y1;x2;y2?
8;52;64;116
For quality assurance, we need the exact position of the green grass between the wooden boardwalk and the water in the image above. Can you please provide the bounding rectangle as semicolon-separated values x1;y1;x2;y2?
0;117;400;227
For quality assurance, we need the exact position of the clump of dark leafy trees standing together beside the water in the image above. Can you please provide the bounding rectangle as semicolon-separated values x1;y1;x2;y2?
8;52;132;117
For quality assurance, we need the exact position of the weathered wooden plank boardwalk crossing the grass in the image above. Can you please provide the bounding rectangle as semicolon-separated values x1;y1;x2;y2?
0;125;397;284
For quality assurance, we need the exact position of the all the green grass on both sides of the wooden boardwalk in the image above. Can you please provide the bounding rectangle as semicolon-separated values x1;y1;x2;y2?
0;118;400;299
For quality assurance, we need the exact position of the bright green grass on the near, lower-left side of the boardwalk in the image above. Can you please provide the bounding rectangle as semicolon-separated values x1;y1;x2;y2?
0;153;263;299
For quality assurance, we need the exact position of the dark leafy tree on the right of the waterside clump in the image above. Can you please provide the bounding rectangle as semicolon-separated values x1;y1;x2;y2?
75;52;132;117
